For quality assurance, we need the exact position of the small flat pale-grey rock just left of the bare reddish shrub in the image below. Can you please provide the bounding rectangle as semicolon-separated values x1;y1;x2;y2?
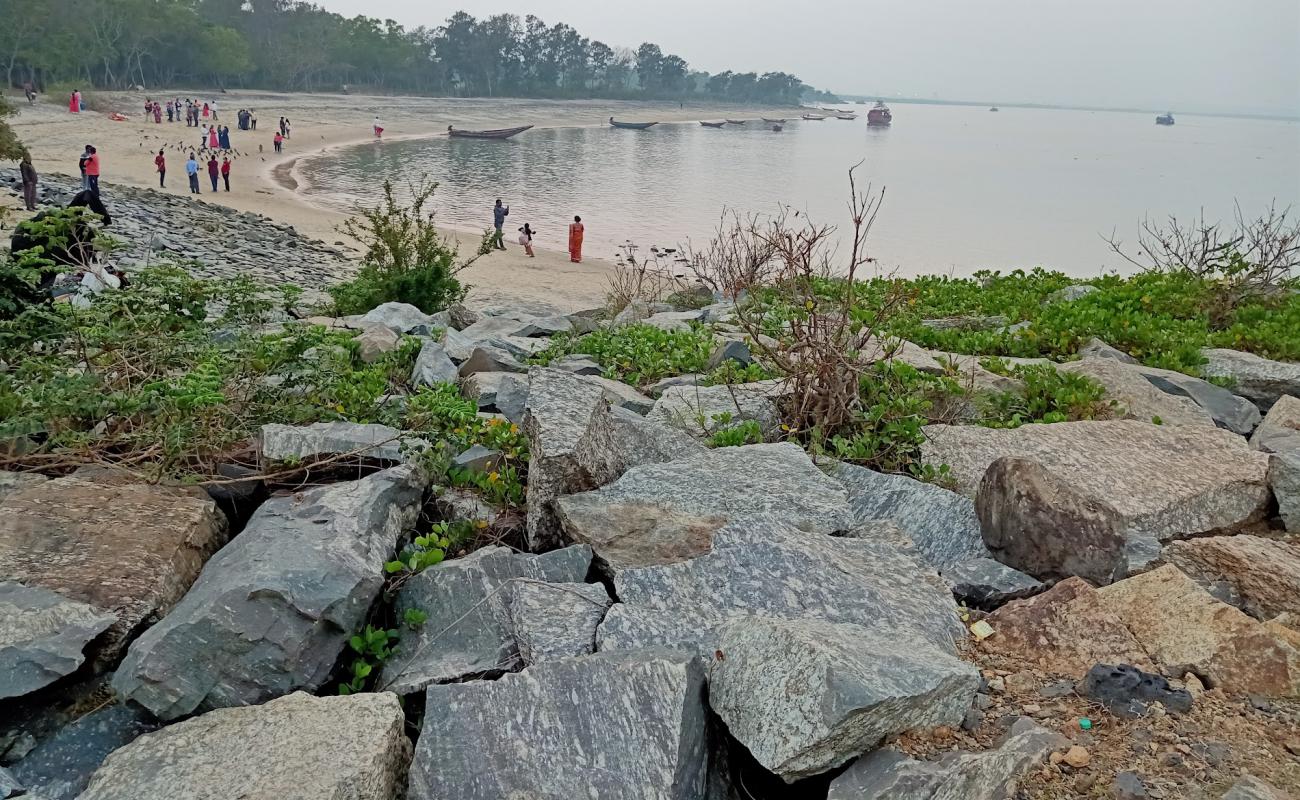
646;380;784;437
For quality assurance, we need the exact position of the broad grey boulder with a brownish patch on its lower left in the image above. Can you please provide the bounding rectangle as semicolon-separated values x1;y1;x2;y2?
555;444;853;570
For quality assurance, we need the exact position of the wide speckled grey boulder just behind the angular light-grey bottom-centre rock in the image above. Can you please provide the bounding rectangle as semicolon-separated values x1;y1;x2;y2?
597;515;965;654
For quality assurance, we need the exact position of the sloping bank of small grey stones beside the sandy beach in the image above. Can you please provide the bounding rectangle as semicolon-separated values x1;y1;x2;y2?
0;169;356;289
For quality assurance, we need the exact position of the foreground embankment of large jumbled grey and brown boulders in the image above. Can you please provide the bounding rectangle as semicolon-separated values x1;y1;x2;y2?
0;297;1300;800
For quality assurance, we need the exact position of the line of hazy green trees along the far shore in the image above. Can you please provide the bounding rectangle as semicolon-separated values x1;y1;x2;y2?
0;0;829;104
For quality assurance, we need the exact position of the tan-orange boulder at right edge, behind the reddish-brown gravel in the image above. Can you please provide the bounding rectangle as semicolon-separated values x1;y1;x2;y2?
1099;565;1300;697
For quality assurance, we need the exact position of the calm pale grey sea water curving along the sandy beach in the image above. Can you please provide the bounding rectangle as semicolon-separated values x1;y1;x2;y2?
299;105;1300;276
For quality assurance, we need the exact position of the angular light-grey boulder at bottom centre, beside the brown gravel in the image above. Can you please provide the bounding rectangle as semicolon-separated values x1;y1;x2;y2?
709;618;979;782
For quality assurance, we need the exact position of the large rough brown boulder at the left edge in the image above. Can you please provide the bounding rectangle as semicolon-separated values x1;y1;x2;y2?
0;473;228;666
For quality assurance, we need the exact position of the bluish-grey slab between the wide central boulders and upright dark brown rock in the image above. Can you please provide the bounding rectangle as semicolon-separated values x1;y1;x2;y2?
831;463;988;571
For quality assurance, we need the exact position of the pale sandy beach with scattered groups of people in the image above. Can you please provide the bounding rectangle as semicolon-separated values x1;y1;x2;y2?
12;90;789;310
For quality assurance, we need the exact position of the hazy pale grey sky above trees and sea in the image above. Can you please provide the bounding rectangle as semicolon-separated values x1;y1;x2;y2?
316;0;1300;114
